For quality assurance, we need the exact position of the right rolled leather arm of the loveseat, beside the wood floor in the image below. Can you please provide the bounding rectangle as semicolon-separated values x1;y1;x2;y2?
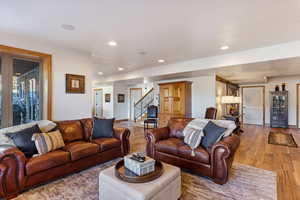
211;135;240;184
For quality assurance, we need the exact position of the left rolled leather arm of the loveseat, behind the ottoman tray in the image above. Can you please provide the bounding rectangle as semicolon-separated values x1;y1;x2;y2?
145;127;170;158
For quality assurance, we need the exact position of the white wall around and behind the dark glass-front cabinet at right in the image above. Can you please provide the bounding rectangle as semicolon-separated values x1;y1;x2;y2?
241;76;300;126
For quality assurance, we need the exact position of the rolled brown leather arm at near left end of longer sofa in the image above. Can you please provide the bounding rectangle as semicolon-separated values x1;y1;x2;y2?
0;145;26;199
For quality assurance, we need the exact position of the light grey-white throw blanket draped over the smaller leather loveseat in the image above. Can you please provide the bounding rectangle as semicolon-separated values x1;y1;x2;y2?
183;119;236;156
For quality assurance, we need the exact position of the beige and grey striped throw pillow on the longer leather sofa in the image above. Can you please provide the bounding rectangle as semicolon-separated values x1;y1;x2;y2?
32;130;65;155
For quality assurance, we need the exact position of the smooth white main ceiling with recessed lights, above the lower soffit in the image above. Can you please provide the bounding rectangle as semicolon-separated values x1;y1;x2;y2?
0;0;300;76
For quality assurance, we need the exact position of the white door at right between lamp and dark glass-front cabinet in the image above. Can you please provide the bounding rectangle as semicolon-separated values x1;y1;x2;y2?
242;87;264;125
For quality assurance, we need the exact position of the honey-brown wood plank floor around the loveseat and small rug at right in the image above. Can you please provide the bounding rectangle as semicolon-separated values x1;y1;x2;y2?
118;122;300;200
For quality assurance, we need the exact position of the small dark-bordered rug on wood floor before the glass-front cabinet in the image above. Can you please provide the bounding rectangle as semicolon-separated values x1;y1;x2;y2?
268;132;298;147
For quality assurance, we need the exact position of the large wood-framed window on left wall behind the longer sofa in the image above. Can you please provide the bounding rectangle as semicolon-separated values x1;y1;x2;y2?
0;45;51;128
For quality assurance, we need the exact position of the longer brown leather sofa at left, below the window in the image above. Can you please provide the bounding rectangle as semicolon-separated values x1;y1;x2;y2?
0;119;130;199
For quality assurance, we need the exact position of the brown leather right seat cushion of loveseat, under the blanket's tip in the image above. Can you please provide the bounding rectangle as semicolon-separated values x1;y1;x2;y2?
178;145;209;164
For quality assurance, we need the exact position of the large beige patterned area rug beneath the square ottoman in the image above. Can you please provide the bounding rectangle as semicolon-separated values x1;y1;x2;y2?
15;160;277;200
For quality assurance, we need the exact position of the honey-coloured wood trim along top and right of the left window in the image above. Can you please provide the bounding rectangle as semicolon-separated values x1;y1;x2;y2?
0;45;53;120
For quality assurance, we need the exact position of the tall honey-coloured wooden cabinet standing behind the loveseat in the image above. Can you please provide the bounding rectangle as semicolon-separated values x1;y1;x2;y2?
159;81;191;117
